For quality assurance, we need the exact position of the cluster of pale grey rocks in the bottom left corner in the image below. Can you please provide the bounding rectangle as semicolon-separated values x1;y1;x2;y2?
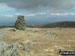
0;42;30;56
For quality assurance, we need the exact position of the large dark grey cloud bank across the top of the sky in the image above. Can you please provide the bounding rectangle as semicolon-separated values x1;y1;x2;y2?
0;0;75;11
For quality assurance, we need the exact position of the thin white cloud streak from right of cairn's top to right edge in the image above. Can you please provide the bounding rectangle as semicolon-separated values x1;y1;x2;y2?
25;13;75;17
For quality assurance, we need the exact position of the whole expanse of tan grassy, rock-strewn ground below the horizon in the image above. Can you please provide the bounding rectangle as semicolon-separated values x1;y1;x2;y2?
0;28;75;56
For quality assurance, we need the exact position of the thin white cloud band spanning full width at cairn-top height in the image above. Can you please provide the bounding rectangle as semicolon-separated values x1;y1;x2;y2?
0;13;75;17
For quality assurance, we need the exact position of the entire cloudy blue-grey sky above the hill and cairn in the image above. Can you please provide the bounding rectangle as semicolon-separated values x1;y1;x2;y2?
0;0;75;26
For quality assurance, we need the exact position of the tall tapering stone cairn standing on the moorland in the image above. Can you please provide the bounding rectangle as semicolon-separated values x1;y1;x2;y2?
15;16;26;30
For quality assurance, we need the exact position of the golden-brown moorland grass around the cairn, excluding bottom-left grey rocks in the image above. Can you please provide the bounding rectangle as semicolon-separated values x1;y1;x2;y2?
0;28;75;56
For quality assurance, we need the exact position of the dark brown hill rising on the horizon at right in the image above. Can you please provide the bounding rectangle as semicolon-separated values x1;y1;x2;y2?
42;21;75;28
